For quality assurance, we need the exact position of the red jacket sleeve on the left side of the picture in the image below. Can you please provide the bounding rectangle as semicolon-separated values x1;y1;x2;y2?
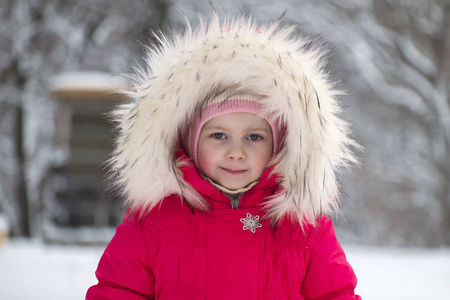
86;216;155;300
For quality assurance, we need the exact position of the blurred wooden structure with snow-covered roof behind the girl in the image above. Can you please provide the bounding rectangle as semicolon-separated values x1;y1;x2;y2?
47;72;127;243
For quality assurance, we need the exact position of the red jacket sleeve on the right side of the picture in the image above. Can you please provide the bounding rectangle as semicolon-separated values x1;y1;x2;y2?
302;217;361;300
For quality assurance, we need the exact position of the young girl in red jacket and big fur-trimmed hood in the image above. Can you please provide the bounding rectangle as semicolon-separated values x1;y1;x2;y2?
86;15;360;300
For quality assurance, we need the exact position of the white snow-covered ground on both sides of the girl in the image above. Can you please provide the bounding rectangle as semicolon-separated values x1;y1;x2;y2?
0;240;450;300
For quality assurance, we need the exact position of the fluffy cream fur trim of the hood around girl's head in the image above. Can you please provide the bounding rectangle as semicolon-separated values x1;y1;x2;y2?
109;14;359;223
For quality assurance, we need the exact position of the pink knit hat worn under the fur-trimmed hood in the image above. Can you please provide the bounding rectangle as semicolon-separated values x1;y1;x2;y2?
187;96;280;166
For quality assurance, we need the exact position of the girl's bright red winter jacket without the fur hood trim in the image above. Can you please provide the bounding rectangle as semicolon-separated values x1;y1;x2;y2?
86;162;361;300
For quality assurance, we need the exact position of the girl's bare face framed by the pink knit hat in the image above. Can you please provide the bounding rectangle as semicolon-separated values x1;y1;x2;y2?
198;112;273;190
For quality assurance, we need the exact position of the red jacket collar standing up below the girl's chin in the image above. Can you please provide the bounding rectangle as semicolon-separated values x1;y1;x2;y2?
177;150;278;209
